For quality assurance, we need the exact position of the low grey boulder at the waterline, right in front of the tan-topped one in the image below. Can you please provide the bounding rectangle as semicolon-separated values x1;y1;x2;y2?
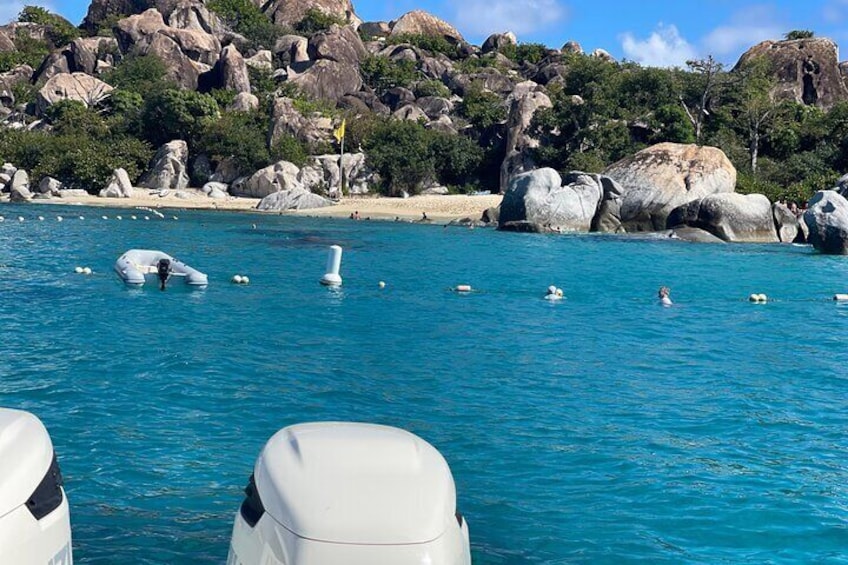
667;192;780;243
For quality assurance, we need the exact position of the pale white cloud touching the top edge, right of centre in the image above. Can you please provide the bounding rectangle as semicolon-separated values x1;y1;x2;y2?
454;0;567;40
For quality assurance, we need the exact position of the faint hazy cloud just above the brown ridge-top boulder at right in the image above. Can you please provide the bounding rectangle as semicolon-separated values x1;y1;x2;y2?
703;6;785;58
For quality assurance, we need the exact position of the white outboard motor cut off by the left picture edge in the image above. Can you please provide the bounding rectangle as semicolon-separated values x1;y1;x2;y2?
0;408;73;565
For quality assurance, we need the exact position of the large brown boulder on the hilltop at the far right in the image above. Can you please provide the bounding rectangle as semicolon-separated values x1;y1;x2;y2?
734;37;848;108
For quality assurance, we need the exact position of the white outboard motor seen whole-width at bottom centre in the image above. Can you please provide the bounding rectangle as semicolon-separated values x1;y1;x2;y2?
227;422;471;565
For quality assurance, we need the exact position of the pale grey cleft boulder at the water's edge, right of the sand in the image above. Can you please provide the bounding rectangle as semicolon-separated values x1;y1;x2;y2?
498;168;603;232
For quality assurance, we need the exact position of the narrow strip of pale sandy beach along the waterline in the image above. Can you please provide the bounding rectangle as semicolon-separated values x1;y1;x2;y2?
23;190;503;222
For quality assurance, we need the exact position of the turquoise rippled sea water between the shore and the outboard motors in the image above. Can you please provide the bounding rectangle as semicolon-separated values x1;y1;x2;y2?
0;205;848;565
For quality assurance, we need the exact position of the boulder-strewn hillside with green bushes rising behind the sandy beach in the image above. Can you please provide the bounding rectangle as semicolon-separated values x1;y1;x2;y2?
0;4;848;235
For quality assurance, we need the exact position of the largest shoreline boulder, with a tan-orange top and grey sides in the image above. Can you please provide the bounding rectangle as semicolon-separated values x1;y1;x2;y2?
601;143;736;232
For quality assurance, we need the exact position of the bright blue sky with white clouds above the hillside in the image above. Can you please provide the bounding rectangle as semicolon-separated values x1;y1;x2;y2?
8;0;848;66
